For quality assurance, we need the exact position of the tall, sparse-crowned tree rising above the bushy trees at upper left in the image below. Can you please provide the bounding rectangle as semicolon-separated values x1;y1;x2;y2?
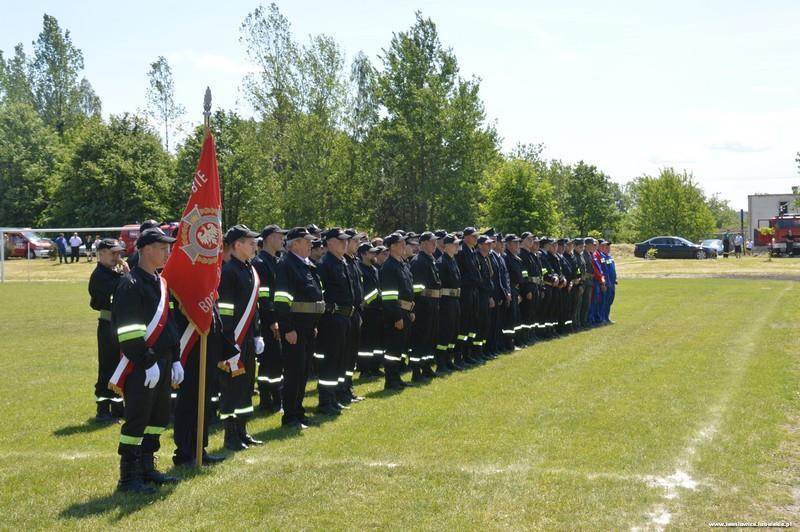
31;14;83;136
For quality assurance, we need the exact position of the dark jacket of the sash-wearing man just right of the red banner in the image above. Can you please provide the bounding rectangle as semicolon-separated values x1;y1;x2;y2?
218;256;260;349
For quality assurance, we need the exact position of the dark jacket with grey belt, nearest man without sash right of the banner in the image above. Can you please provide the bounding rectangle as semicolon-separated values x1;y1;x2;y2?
273;252;327;334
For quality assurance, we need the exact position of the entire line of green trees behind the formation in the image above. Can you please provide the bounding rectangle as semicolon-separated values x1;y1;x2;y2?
0;4;738;241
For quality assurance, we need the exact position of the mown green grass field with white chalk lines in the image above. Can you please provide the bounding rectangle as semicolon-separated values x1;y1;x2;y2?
0;278;800;530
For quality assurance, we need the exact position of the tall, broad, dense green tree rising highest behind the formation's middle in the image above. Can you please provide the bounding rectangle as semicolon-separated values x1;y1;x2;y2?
371;13;498;231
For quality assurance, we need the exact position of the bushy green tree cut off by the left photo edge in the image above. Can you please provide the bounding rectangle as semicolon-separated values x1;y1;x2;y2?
0;101;60;227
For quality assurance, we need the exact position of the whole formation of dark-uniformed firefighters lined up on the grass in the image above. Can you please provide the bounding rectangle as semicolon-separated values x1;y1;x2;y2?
97;224;617;493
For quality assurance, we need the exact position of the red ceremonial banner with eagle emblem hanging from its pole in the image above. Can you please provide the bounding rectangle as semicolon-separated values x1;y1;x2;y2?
162;133;223;334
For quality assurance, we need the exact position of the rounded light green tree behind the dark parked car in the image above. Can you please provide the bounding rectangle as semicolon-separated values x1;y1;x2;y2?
629;168;714;241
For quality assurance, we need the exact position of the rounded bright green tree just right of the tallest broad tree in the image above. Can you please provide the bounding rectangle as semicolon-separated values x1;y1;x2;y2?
484;159;558;235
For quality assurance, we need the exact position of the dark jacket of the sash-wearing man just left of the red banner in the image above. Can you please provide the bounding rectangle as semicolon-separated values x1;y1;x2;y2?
112;266;180;369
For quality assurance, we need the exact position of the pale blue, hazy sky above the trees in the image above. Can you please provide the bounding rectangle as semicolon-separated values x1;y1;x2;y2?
0;0;800;208
